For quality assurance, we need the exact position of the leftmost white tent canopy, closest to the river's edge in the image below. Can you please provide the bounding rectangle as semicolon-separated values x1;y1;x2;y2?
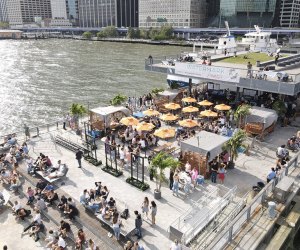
90;106;131;126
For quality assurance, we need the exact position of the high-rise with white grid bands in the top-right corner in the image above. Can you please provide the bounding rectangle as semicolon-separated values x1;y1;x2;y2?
280;0;300;28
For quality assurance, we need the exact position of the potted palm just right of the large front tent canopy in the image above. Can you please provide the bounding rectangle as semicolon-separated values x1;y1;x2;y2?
223;129;247;168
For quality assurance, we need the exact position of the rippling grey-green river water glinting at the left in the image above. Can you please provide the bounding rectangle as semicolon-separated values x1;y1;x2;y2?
0;39;191;135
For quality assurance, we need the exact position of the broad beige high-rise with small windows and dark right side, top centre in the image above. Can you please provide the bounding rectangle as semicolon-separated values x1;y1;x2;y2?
139;0;206;28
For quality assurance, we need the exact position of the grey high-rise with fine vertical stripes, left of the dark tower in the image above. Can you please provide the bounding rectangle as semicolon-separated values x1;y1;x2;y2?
78;0;117;27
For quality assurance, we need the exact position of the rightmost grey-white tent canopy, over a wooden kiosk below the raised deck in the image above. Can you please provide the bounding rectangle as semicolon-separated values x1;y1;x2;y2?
246;107;278;129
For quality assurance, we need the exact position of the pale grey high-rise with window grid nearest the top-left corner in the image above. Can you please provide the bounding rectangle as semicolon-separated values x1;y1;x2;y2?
6;0;52;26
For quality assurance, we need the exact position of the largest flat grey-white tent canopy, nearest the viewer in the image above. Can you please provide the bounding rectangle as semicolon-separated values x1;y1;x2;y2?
181;131;230;160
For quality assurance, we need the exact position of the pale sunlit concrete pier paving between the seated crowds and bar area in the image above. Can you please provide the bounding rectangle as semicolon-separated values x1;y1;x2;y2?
1;118;299;250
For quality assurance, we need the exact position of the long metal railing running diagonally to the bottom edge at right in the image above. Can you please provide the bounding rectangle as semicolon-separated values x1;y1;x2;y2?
206;152;300;250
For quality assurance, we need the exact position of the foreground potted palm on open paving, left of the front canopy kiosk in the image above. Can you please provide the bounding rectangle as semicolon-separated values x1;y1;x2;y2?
149;152;180;199
